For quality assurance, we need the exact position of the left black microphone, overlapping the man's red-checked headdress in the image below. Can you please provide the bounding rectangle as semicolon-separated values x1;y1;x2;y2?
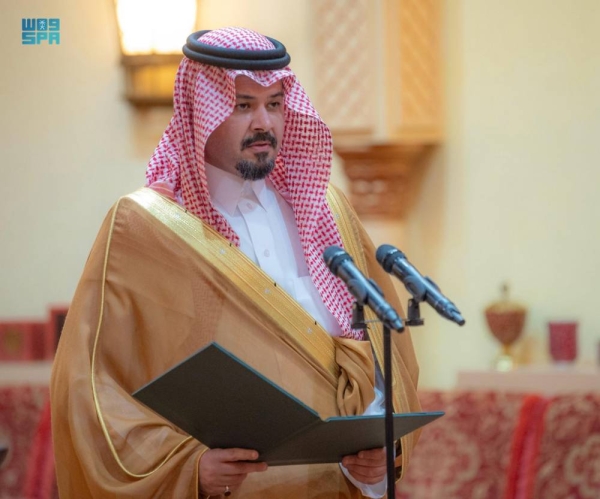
323;246;404;331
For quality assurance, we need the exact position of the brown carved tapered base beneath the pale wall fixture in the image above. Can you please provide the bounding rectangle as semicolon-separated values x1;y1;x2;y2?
335;143;434;219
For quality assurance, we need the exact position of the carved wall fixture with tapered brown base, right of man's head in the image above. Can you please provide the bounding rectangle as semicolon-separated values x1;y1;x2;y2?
312;0;443;218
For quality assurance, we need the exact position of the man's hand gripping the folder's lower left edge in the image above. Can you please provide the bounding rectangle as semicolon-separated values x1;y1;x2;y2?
200;449;268;496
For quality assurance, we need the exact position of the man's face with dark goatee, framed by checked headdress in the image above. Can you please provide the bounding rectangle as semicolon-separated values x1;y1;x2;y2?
204;76;285;180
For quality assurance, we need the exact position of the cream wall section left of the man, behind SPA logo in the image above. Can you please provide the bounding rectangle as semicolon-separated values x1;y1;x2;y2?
0;0;151;317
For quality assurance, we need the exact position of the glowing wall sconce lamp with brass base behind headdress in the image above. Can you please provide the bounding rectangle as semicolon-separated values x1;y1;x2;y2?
114;0;198;107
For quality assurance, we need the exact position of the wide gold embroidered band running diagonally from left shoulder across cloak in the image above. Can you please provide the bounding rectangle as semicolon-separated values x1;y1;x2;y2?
126;188;339;387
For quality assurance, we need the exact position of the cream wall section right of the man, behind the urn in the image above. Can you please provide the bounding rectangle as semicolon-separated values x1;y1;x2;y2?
406;0;600;386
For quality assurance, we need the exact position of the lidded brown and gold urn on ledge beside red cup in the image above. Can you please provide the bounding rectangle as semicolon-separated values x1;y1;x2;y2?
485;284;527;371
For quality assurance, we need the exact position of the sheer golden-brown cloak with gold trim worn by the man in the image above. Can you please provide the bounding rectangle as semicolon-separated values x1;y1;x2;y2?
51;188;420;499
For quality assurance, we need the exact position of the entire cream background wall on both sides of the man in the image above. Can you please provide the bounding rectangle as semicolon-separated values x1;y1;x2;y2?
0;0;600;387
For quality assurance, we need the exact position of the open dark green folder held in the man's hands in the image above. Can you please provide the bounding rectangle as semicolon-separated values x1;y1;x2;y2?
133;343;444;466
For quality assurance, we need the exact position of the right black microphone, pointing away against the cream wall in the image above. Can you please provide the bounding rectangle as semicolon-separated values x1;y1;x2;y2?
375;244;465;326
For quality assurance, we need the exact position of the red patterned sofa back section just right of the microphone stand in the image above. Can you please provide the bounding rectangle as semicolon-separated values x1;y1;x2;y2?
399;391;542;499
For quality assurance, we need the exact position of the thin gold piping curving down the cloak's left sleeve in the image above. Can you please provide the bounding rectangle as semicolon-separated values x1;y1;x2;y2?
91;200;192;478
